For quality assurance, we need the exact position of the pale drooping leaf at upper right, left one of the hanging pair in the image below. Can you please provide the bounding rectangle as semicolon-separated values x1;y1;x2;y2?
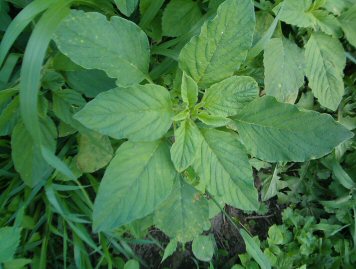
263;38;304;103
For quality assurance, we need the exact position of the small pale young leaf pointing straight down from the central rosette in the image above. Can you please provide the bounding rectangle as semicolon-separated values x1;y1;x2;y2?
171;119;201;172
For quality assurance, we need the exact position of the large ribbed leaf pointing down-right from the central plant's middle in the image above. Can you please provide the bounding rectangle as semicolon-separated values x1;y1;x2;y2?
193;129;258;210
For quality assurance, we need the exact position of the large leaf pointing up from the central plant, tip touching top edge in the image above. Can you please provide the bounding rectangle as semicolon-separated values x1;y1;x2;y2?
179;0;255;86
